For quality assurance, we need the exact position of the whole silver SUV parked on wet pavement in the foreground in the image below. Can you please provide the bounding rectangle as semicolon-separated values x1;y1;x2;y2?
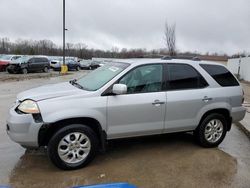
7;59;245;170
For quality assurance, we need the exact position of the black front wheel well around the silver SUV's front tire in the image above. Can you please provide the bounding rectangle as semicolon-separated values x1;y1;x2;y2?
38;117;107;150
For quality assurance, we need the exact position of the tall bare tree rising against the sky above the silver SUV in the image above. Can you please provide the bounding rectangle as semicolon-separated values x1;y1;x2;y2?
164;22;176;56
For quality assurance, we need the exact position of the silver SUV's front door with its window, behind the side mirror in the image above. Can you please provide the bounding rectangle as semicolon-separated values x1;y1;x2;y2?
107;64;166;138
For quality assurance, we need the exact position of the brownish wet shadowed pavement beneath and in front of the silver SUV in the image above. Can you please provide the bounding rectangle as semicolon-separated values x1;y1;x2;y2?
10;133;237;187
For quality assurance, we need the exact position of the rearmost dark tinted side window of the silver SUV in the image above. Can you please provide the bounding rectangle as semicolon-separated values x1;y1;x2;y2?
200;64;239;87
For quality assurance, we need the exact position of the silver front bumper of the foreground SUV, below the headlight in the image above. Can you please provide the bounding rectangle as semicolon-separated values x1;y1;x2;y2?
7;107;43;148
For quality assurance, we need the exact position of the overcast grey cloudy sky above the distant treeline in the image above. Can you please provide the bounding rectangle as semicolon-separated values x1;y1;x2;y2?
0;0;250;54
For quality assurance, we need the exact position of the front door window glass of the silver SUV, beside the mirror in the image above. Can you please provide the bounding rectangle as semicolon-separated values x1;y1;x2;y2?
119;64;162;94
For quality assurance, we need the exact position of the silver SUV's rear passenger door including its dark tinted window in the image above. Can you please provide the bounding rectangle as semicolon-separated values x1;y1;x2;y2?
164;63;211;132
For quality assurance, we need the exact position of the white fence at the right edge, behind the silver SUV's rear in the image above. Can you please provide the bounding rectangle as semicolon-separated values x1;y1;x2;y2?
227;57;250;82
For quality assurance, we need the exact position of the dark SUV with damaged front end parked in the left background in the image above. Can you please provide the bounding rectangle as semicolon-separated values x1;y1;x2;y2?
7;56;50;74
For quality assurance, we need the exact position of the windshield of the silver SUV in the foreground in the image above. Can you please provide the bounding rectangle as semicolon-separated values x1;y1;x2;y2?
76;62;129;91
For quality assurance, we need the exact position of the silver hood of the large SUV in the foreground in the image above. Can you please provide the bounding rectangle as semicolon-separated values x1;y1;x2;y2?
17;82;87;101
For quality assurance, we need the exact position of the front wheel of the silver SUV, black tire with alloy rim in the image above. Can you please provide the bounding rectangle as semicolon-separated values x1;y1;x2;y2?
48;124;98;170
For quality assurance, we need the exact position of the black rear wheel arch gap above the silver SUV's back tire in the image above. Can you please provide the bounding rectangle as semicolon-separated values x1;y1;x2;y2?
199;108;232;131
